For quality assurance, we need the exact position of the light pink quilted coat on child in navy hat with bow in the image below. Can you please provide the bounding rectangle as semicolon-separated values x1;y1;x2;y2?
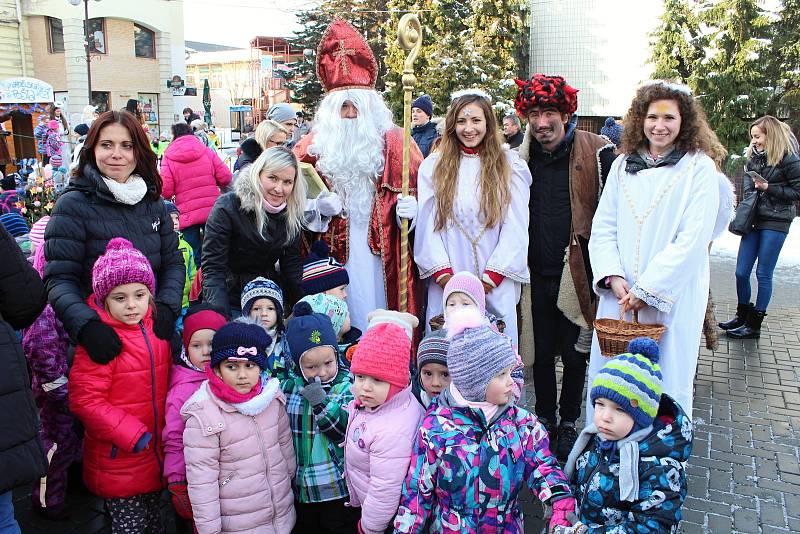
181;379;296;534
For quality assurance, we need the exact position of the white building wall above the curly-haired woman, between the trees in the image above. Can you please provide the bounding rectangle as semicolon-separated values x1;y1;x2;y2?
531;0;663;117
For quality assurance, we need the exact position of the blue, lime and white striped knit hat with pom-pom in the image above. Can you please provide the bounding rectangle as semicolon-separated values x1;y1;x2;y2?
588;337;662;428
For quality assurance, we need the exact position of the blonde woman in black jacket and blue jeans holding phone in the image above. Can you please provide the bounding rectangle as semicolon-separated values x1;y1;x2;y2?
719;115;800;339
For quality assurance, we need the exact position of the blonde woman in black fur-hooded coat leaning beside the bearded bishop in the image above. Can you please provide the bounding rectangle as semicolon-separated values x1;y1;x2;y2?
202;147;306;316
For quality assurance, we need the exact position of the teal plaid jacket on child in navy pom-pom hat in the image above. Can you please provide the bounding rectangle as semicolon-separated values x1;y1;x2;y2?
281;366;353;503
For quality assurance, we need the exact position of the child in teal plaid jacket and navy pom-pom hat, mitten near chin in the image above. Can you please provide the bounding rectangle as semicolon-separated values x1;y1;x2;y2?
281;301;359;532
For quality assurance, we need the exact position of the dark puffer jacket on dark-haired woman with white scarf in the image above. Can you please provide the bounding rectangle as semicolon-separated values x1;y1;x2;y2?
44;165;186;343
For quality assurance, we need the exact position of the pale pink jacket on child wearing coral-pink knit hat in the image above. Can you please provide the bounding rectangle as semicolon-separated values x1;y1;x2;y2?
344;386;425;534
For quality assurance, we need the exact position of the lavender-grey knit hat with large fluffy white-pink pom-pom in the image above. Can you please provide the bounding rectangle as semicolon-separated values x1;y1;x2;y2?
447;308;517;402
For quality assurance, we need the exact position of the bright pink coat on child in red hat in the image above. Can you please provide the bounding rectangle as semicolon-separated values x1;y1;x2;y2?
164;365;206;483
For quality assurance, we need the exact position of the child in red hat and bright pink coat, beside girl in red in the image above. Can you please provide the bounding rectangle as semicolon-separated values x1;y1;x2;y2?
164;304;227;520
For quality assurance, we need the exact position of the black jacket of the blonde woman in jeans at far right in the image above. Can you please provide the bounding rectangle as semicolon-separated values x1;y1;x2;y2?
743;154;800;233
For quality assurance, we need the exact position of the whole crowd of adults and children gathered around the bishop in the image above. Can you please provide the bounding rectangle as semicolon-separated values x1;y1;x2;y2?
0;16;800;534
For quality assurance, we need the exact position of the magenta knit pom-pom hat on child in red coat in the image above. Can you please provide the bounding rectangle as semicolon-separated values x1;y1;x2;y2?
92;237;156;306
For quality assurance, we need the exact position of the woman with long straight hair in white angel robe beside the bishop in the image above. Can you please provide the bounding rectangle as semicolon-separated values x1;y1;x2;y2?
414;90;531;343
